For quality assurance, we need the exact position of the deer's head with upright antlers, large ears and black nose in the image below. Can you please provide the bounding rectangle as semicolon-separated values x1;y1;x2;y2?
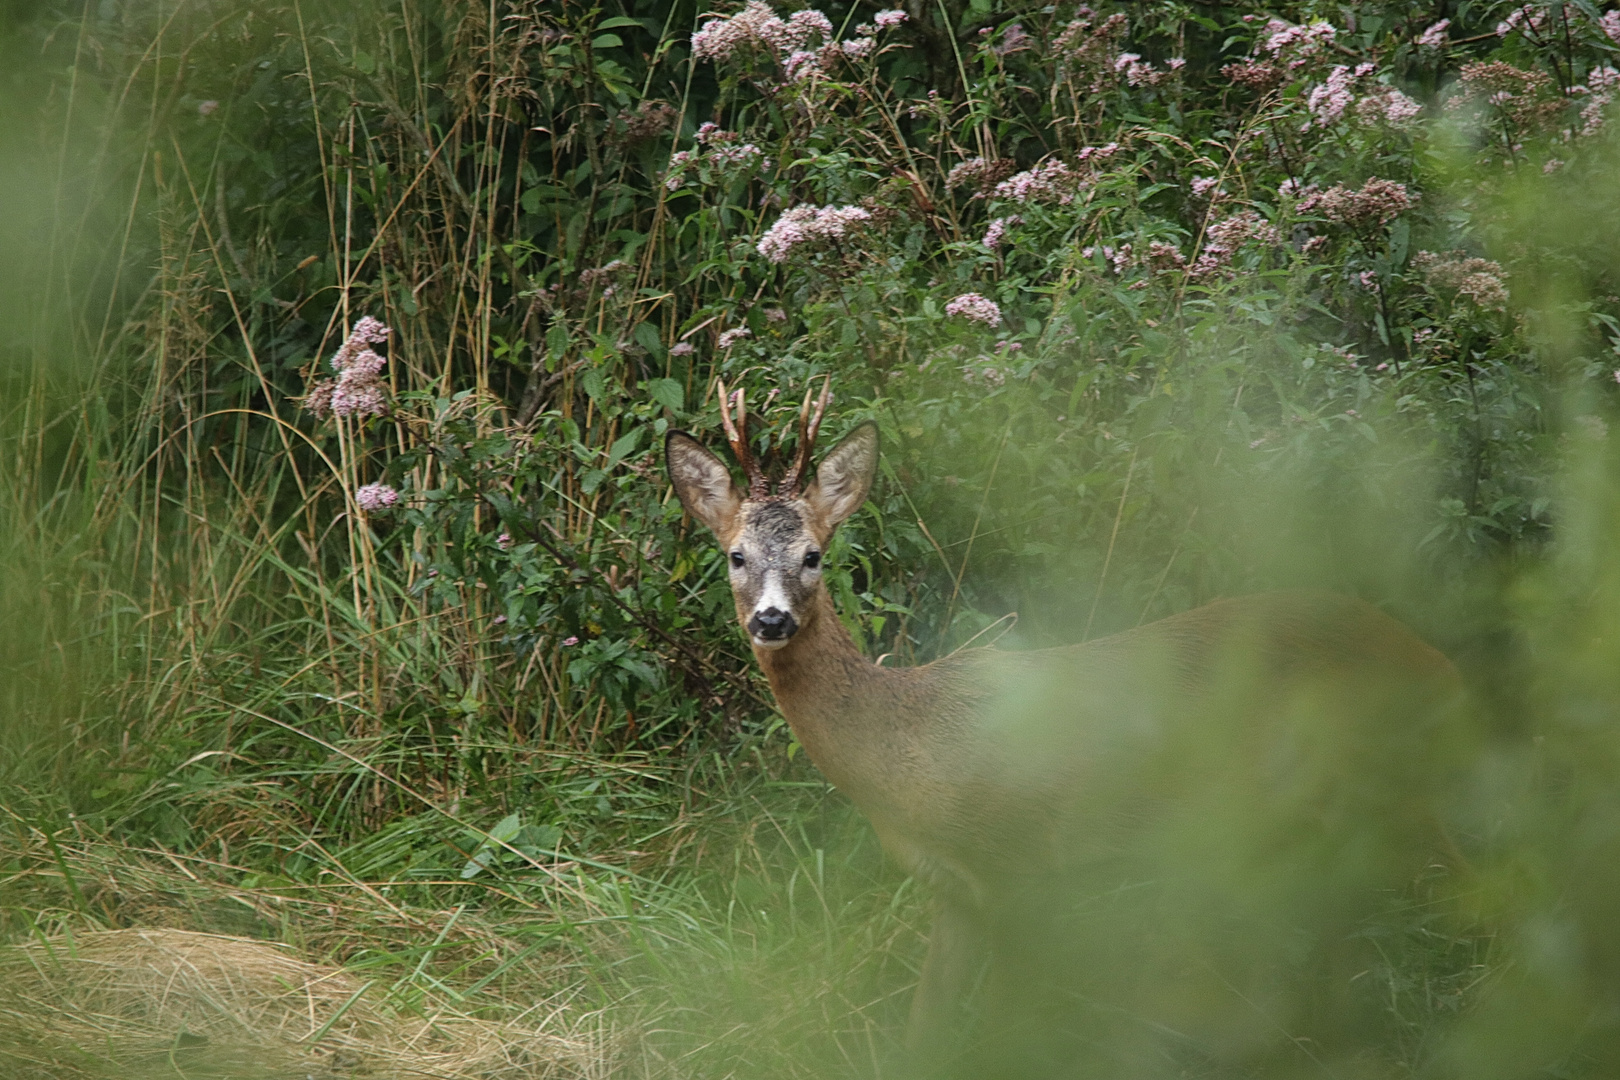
664;384;878;649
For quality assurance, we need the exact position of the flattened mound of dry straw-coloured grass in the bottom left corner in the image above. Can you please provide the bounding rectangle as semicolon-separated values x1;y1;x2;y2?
0;929;608;1080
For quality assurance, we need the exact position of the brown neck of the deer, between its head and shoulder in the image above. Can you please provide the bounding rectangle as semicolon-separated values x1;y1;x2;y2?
753;589;928;813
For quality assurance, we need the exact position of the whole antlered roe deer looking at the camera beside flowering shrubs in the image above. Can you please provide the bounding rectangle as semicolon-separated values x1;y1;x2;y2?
666;385;1458;1075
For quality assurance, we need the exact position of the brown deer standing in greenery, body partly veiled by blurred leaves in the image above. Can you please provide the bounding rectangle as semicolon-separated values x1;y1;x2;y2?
667;393;1456;1052
